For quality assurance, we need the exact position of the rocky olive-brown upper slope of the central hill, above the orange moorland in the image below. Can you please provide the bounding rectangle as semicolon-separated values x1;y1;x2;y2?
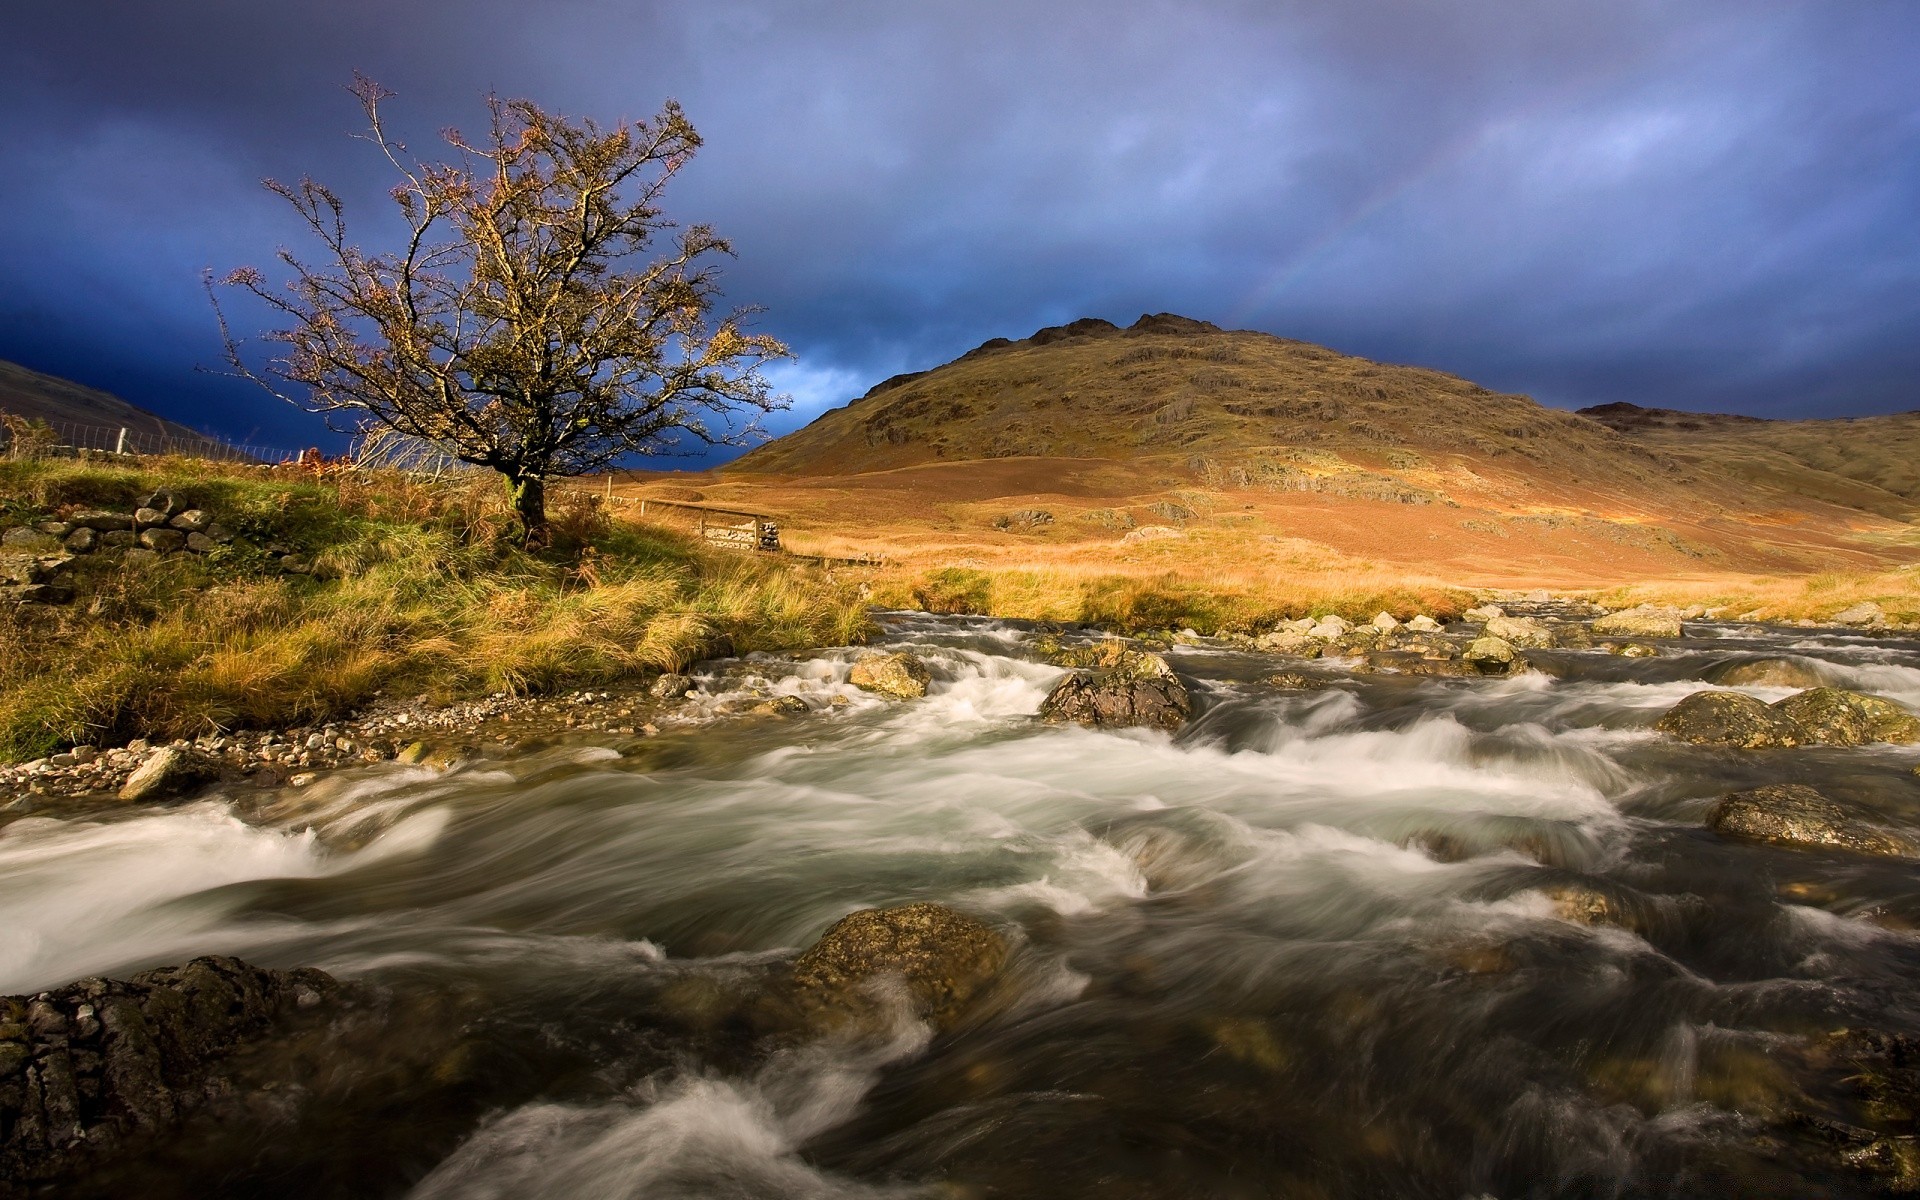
733;313;1674;484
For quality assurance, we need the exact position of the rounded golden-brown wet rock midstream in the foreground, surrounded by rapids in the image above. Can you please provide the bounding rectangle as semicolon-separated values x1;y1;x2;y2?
793;904;1008;1029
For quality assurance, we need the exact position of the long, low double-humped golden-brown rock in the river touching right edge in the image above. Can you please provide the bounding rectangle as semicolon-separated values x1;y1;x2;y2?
1653;687;1920;751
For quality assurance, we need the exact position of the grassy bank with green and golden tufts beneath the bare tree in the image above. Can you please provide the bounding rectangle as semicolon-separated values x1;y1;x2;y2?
0;461;868;760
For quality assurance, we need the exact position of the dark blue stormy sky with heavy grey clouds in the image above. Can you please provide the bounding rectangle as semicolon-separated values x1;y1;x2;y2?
0;0;1920;462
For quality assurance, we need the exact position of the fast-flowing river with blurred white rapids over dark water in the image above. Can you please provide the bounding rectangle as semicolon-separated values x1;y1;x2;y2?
0;614;1920;1200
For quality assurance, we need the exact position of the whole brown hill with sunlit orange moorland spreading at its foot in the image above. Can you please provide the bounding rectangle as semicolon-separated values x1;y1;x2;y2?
616;313;1920;624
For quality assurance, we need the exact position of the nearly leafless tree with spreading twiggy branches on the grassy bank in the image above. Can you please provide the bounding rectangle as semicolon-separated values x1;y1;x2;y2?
220;77;787;547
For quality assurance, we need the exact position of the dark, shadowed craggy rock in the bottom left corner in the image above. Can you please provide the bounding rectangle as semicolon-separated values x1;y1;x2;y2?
0;958;348;1192
